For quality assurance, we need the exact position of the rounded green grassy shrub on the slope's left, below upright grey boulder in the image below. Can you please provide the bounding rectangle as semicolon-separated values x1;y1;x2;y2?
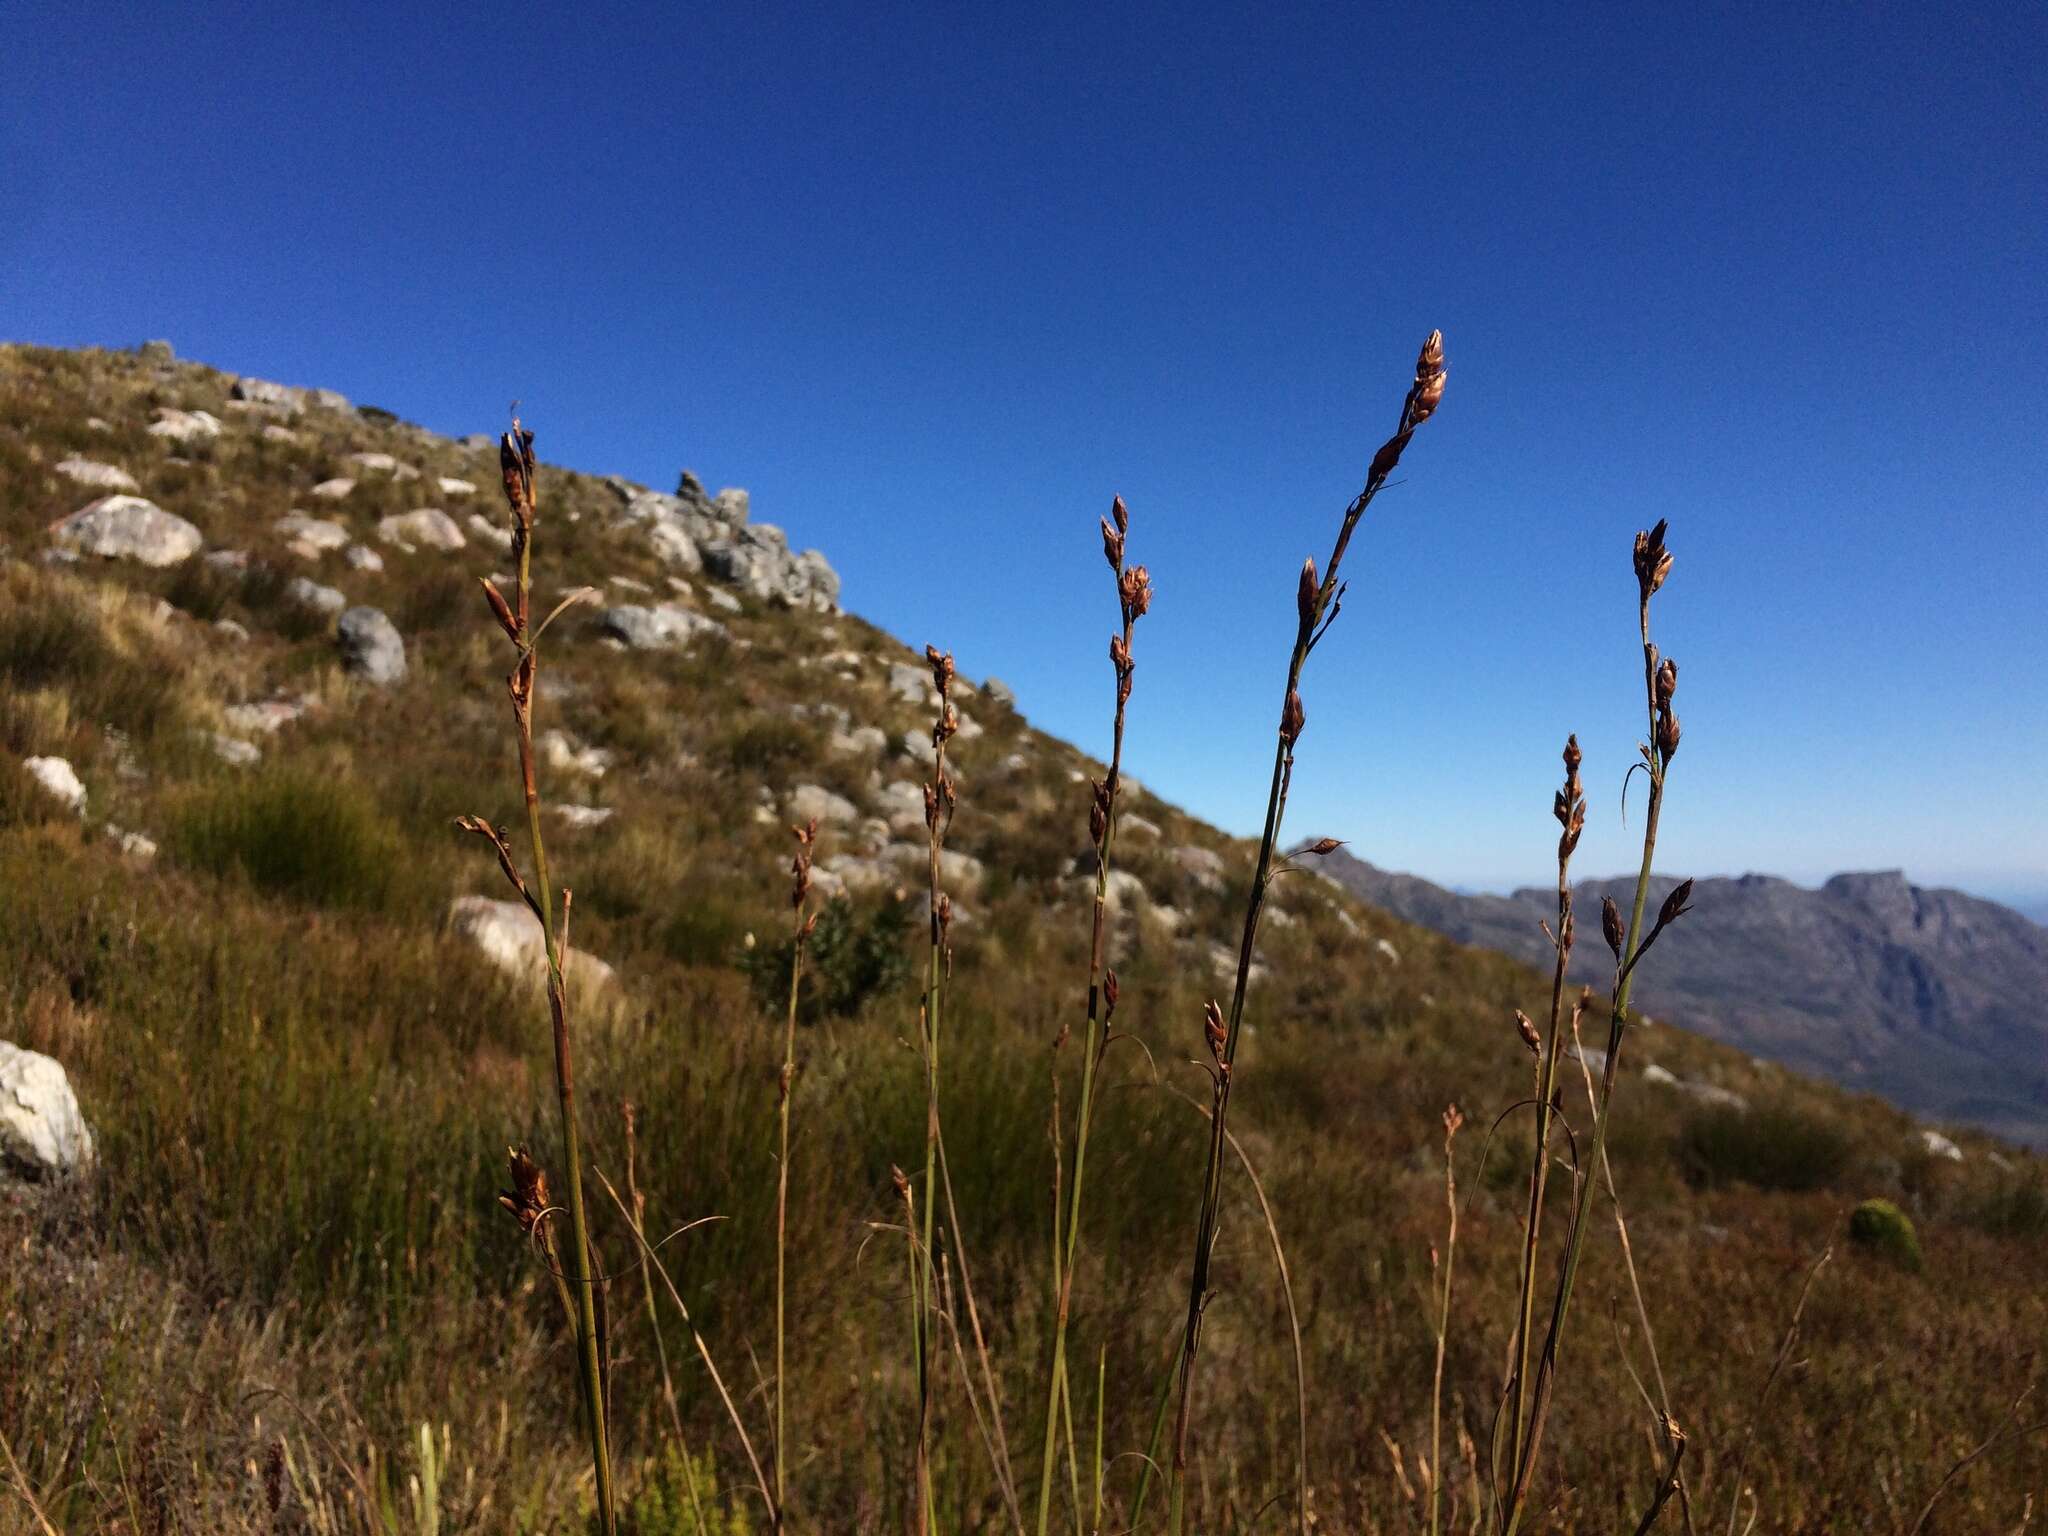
172;770;401;909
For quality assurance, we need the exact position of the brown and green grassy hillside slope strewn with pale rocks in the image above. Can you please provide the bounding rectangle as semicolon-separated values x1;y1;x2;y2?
0;346;2048;1532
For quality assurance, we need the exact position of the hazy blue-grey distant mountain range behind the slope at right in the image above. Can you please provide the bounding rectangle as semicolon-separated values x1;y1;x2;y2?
1321;850;2048;1145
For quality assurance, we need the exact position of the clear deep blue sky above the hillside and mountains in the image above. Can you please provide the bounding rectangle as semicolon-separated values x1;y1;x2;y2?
0;2;2048;895
